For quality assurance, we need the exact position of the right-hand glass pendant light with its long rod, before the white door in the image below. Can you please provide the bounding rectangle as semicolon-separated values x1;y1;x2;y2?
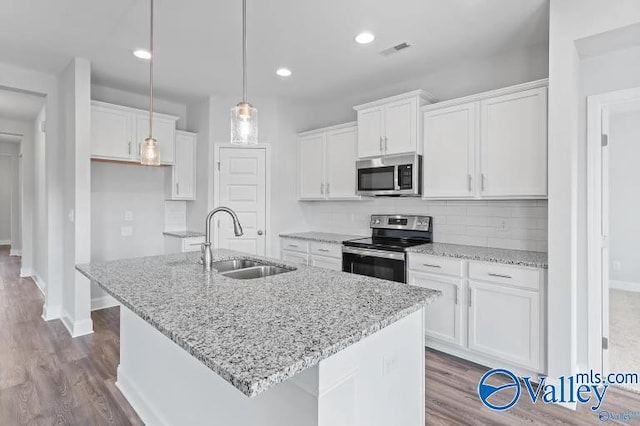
231;0;258;145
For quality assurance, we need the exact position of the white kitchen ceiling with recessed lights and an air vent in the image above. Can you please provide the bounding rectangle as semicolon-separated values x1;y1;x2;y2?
0;0;549;100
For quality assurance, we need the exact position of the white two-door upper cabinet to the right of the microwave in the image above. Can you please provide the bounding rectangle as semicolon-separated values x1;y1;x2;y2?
422;80;547;199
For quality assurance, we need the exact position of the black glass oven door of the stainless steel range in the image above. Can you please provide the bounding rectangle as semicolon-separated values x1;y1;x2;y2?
342;247;406;283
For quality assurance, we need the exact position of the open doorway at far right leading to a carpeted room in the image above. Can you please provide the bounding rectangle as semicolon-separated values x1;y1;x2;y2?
588;88;640;393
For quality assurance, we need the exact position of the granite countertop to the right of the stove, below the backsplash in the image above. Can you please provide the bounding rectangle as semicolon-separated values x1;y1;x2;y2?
407;243;548;269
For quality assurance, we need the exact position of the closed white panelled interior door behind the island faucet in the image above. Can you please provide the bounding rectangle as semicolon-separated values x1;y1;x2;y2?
214;147;267;255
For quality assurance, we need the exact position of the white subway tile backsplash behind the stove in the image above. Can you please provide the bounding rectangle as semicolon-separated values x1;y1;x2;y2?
301;198;548;252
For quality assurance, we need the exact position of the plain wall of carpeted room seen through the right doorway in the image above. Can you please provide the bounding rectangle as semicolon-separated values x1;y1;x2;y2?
609;108;640;291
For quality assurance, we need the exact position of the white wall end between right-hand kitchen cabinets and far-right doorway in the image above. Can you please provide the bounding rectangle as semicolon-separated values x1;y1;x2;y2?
548;0;640;377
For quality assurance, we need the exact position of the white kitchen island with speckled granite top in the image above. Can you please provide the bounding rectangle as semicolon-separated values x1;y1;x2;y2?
77;250;439;426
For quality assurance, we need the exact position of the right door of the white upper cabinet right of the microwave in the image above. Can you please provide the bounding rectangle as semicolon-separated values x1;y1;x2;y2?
480;88;547;197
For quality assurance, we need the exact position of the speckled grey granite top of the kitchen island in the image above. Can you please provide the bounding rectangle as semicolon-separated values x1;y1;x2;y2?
77;250;440;396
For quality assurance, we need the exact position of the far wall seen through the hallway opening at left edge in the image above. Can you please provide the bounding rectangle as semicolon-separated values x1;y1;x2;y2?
0;142;21;245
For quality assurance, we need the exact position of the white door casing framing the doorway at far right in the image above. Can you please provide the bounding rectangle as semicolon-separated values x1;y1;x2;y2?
587;87;640;371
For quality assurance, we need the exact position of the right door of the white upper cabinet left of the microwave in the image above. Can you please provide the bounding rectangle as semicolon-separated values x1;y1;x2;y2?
325;127;360;199
